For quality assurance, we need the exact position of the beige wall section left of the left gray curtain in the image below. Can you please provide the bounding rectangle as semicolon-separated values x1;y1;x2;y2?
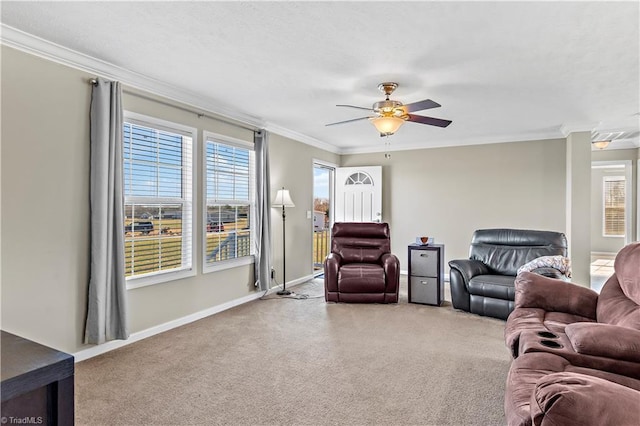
1;47;89;351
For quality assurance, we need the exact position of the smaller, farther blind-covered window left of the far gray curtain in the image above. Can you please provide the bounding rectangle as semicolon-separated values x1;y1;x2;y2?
203;132;255;272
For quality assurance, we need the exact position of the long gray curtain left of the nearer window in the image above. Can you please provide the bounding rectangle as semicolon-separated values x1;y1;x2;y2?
84;78;129;344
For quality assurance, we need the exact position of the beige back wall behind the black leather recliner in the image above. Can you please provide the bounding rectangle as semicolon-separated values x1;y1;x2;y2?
342;139;565;266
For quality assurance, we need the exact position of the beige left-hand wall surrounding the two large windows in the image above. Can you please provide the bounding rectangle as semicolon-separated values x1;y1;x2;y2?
1;46;339;352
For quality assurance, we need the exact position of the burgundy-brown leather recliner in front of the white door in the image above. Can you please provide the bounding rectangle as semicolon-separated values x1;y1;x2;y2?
324;222;400;303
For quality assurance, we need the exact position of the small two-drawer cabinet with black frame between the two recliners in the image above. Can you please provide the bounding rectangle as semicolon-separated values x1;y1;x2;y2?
409;244;444;306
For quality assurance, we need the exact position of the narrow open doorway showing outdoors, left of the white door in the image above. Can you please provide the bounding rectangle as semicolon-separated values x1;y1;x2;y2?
312;161;336;276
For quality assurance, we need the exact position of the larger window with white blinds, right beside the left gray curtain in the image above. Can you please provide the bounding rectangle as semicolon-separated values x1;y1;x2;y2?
123;113;195;287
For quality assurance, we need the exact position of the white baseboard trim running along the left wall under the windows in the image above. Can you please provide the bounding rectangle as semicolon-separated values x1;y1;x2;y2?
73;274;313;362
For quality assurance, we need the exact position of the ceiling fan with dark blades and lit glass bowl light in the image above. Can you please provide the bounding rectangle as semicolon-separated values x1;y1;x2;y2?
327;82;452;136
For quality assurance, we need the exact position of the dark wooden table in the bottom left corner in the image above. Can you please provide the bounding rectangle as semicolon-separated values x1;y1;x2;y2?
0;331;74;426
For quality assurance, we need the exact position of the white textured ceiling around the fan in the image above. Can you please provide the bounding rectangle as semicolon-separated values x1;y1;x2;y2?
1;1;640;153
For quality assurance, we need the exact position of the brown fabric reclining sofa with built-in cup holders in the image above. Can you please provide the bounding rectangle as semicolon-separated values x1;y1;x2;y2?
505;243;640;425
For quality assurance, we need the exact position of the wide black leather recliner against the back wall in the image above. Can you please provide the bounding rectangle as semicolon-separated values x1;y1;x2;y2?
449;229;567;320
